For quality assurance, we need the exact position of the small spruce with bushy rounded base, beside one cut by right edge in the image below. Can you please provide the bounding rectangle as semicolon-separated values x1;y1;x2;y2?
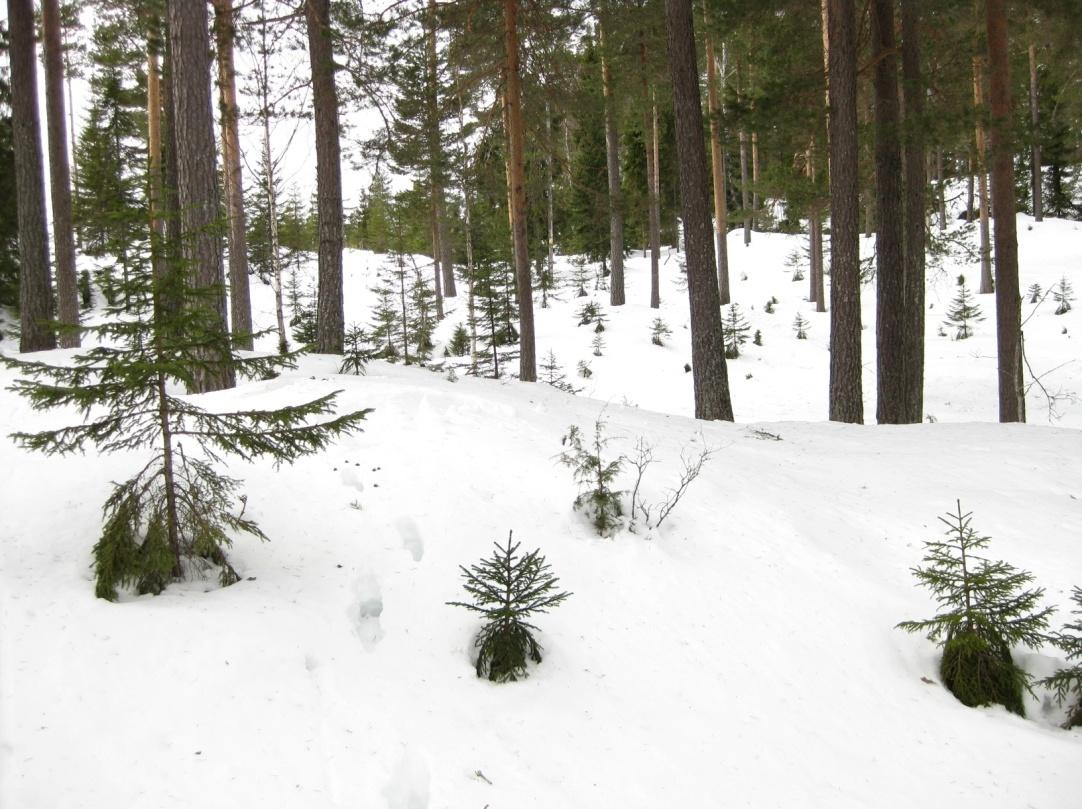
898;502;1054;716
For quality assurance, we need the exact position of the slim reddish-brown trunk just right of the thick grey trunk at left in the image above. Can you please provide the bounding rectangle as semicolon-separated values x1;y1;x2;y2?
212;0;252;350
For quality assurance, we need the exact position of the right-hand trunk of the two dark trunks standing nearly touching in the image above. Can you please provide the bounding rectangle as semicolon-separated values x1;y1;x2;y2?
901;0;927;424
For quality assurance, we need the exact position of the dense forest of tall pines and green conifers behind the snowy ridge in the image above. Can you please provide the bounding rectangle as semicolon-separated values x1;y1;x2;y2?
0;0;1082;423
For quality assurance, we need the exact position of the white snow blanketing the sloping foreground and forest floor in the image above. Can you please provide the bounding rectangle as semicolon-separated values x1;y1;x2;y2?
0;216;1082;809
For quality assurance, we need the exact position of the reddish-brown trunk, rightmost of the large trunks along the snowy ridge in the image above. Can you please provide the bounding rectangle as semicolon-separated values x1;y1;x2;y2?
985;0;1026;422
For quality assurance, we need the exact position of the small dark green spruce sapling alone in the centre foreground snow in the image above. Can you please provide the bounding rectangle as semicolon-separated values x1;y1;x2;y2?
447;531;571;682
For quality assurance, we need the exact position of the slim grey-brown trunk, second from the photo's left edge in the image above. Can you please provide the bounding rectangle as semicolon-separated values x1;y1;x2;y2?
41;0;80;348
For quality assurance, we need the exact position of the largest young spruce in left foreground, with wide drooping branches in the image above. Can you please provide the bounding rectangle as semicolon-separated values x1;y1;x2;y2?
2;262;370;600
